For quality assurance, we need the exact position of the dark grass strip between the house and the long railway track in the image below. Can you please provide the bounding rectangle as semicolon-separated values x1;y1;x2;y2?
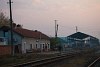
0;54;56;67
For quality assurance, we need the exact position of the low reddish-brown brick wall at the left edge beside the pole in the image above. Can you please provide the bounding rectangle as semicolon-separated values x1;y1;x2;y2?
0;45;11;55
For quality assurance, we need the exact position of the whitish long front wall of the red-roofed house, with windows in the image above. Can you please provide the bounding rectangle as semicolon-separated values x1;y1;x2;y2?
22;37;50;53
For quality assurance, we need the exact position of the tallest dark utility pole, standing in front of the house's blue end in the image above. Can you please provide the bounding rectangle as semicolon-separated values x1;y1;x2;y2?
9;0;14;56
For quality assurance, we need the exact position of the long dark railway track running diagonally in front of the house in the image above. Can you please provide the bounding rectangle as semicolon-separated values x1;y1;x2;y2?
12;52;81;67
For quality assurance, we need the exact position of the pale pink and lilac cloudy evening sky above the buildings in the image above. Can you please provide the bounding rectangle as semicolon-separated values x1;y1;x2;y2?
0;0;100;38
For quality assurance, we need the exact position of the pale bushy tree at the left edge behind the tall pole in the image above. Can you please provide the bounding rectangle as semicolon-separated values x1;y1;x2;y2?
0;12;10;28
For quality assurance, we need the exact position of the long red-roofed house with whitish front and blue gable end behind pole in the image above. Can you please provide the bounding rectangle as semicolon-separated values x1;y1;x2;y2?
0;28;50;53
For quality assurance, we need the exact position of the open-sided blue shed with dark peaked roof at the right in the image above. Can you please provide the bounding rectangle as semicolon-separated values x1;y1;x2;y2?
67;32;99;48
